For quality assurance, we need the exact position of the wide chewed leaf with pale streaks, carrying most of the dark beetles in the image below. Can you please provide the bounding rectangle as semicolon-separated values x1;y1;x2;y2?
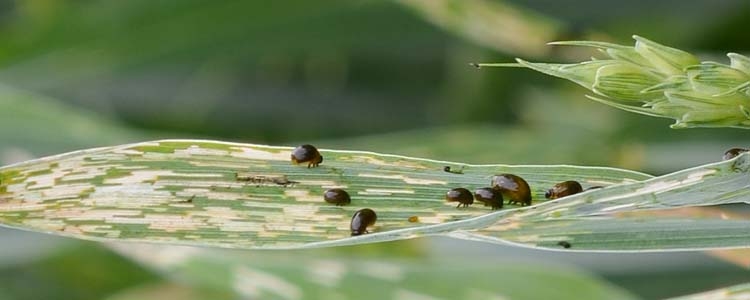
0;140;650;248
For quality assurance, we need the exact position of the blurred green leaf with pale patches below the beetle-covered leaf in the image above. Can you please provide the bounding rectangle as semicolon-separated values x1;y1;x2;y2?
114;244;634;300
